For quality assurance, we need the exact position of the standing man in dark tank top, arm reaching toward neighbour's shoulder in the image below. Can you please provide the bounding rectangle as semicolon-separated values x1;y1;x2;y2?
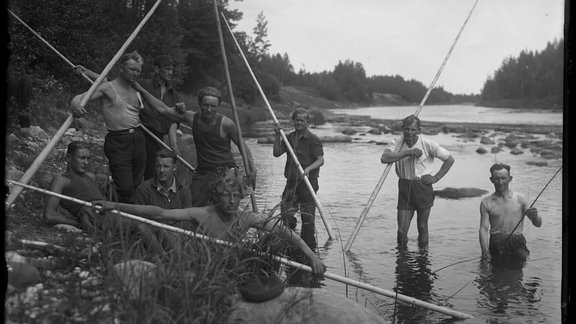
135;84;256;206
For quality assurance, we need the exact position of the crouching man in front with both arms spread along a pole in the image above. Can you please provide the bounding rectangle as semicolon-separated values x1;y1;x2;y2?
97;170;326;275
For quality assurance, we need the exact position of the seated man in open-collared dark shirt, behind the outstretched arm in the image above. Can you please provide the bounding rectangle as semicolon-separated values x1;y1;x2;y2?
130;148;192;209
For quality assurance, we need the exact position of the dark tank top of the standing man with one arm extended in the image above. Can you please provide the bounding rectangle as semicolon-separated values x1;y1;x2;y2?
192;113;236;171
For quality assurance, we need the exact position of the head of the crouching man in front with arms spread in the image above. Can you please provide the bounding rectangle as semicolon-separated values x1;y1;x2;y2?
213;172;244;216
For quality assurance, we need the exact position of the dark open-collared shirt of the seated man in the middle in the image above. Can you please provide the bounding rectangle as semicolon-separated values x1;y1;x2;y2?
130;177;192;209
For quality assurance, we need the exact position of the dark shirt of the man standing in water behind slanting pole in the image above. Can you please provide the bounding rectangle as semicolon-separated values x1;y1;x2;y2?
281;129;324;179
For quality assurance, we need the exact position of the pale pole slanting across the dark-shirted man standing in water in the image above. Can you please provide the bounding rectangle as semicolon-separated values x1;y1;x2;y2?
222;13;335;240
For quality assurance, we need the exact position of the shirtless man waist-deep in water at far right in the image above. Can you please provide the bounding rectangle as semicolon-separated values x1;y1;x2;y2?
479;163;542;261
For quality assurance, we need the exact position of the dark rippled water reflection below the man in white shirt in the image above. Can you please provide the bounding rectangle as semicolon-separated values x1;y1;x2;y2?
395;246;436;323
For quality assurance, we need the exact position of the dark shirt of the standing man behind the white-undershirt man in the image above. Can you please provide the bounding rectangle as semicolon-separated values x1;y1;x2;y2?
138;75;180;135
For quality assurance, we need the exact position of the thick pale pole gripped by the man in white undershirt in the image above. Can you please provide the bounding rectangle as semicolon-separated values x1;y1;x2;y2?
5;0;162;209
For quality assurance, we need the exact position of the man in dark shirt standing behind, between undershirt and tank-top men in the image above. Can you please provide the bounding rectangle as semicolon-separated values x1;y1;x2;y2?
138;55;180;180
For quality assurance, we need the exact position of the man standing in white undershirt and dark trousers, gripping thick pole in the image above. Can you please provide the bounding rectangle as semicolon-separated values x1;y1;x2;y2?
71;52;172;202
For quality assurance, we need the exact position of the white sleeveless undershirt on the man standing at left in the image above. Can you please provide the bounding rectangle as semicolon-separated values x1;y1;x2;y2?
101;82;144;131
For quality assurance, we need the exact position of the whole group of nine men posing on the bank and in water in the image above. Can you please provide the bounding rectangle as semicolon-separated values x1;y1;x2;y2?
45;52;541;273
